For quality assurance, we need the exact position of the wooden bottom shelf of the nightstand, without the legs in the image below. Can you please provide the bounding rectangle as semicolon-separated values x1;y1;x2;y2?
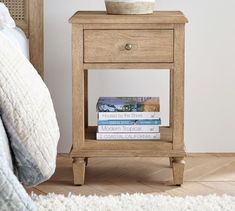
71;127;185;157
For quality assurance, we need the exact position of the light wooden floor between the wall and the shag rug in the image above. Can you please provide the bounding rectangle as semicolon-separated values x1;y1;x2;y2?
27;154;235;196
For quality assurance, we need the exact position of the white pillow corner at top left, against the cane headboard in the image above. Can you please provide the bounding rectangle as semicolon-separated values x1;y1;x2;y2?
0;3;16;30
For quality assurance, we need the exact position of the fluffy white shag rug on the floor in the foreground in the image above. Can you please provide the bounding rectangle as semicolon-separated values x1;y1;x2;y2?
32;193;235;211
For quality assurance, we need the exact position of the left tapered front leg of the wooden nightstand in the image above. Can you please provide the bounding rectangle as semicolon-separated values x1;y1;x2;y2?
73;158;86;185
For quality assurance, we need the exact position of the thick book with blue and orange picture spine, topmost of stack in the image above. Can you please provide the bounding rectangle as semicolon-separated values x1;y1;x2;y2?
96;97;160;112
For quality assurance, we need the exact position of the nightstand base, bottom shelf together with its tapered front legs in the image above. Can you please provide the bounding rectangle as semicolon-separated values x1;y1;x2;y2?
70;127;186;185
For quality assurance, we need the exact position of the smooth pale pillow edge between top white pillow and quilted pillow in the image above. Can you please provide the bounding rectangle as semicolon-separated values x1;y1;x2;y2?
0;27;29;59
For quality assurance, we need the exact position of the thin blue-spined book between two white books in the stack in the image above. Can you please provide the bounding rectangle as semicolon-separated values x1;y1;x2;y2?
98;118;161;125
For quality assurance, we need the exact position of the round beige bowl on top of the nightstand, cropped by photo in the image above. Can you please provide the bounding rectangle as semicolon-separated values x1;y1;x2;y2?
105;0;155;15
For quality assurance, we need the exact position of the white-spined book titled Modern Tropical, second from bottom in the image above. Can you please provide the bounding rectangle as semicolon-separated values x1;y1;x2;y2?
98;125;159;133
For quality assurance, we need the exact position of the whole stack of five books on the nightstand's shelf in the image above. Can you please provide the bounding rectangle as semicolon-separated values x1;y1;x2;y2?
96;97;161;140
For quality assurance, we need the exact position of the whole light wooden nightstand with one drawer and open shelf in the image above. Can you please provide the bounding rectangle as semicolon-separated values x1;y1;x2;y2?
70;11;187;185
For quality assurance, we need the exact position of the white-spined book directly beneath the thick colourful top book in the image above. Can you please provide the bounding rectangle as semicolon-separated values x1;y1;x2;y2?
98;112;160;120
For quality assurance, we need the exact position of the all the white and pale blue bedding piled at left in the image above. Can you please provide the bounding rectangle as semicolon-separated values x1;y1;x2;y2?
0;2;45;211
